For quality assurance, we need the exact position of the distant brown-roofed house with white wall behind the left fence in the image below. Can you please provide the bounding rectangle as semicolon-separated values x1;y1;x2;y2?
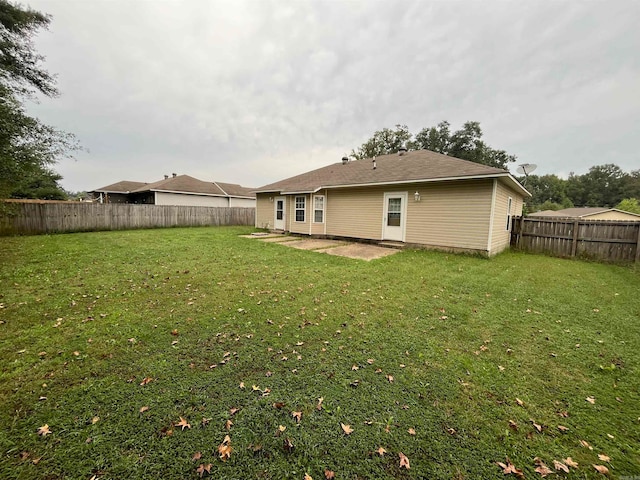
89;174;256;208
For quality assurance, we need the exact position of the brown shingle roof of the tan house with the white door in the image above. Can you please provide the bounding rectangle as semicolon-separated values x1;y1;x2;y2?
255;150;528;195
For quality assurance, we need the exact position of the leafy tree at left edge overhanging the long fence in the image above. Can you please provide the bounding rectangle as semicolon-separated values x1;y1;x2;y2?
0;0;78;198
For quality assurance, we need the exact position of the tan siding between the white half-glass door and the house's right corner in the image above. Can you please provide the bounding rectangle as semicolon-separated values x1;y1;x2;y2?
406;180;493;251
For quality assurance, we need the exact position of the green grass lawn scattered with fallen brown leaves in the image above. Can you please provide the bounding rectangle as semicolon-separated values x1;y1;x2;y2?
0;228;640;480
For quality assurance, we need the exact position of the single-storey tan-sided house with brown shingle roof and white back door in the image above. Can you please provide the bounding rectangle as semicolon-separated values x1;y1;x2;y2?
256;150;530;255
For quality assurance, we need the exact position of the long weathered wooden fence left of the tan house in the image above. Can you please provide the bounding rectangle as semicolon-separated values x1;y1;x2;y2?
0;202;255;236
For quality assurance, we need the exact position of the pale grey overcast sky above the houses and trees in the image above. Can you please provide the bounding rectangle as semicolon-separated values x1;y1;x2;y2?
23;0;640;191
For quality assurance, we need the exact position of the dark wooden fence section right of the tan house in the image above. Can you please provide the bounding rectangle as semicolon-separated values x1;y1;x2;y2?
511;217;640;263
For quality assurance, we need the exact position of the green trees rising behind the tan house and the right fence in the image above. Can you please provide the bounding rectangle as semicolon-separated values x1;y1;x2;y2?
351;121;640;213
